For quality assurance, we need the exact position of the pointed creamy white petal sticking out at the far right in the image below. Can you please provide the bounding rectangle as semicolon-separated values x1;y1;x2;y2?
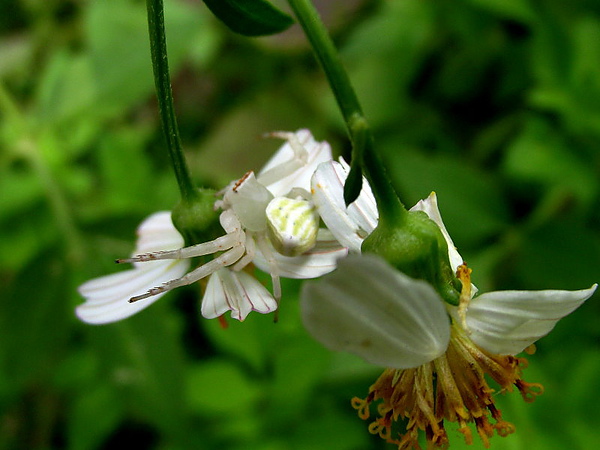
467;285;597;355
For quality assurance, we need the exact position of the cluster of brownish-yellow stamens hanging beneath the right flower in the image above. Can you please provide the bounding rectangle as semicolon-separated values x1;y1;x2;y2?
351;324;543;450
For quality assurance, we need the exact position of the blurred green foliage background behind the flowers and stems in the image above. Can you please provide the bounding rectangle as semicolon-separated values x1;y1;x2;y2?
0;0;600;450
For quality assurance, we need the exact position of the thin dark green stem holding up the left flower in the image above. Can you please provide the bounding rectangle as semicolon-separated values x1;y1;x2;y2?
146;0;197;203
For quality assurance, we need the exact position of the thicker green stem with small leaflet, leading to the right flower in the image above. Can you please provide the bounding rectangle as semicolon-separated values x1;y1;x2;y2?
288;0;406;222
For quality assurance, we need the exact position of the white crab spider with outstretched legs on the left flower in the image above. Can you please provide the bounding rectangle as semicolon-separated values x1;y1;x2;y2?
118;176;319;303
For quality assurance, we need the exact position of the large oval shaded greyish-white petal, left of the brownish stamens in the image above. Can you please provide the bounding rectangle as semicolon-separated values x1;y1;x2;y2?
301;254;450;369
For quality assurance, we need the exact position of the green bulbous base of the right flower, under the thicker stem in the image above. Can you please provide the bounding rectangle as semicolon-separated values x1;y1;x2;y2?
362;211;461;305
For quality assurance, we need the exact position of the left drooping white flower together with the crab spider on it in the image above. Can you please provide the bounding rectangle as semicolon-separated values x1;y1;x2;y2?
77;130;348;323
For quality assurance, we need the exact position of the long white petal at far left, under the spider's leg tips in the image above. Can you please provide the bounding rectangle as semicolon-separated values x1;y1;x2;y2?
75;260;189;324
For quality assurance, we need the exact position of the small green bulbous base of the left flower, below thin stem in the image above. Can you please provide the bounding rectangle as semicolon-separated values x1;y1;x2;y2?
171;189;223;245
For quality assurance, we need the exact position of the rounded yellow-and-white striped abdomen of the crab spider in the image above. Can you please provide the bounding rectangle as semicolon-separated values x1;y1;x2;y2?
266;197;319;256
